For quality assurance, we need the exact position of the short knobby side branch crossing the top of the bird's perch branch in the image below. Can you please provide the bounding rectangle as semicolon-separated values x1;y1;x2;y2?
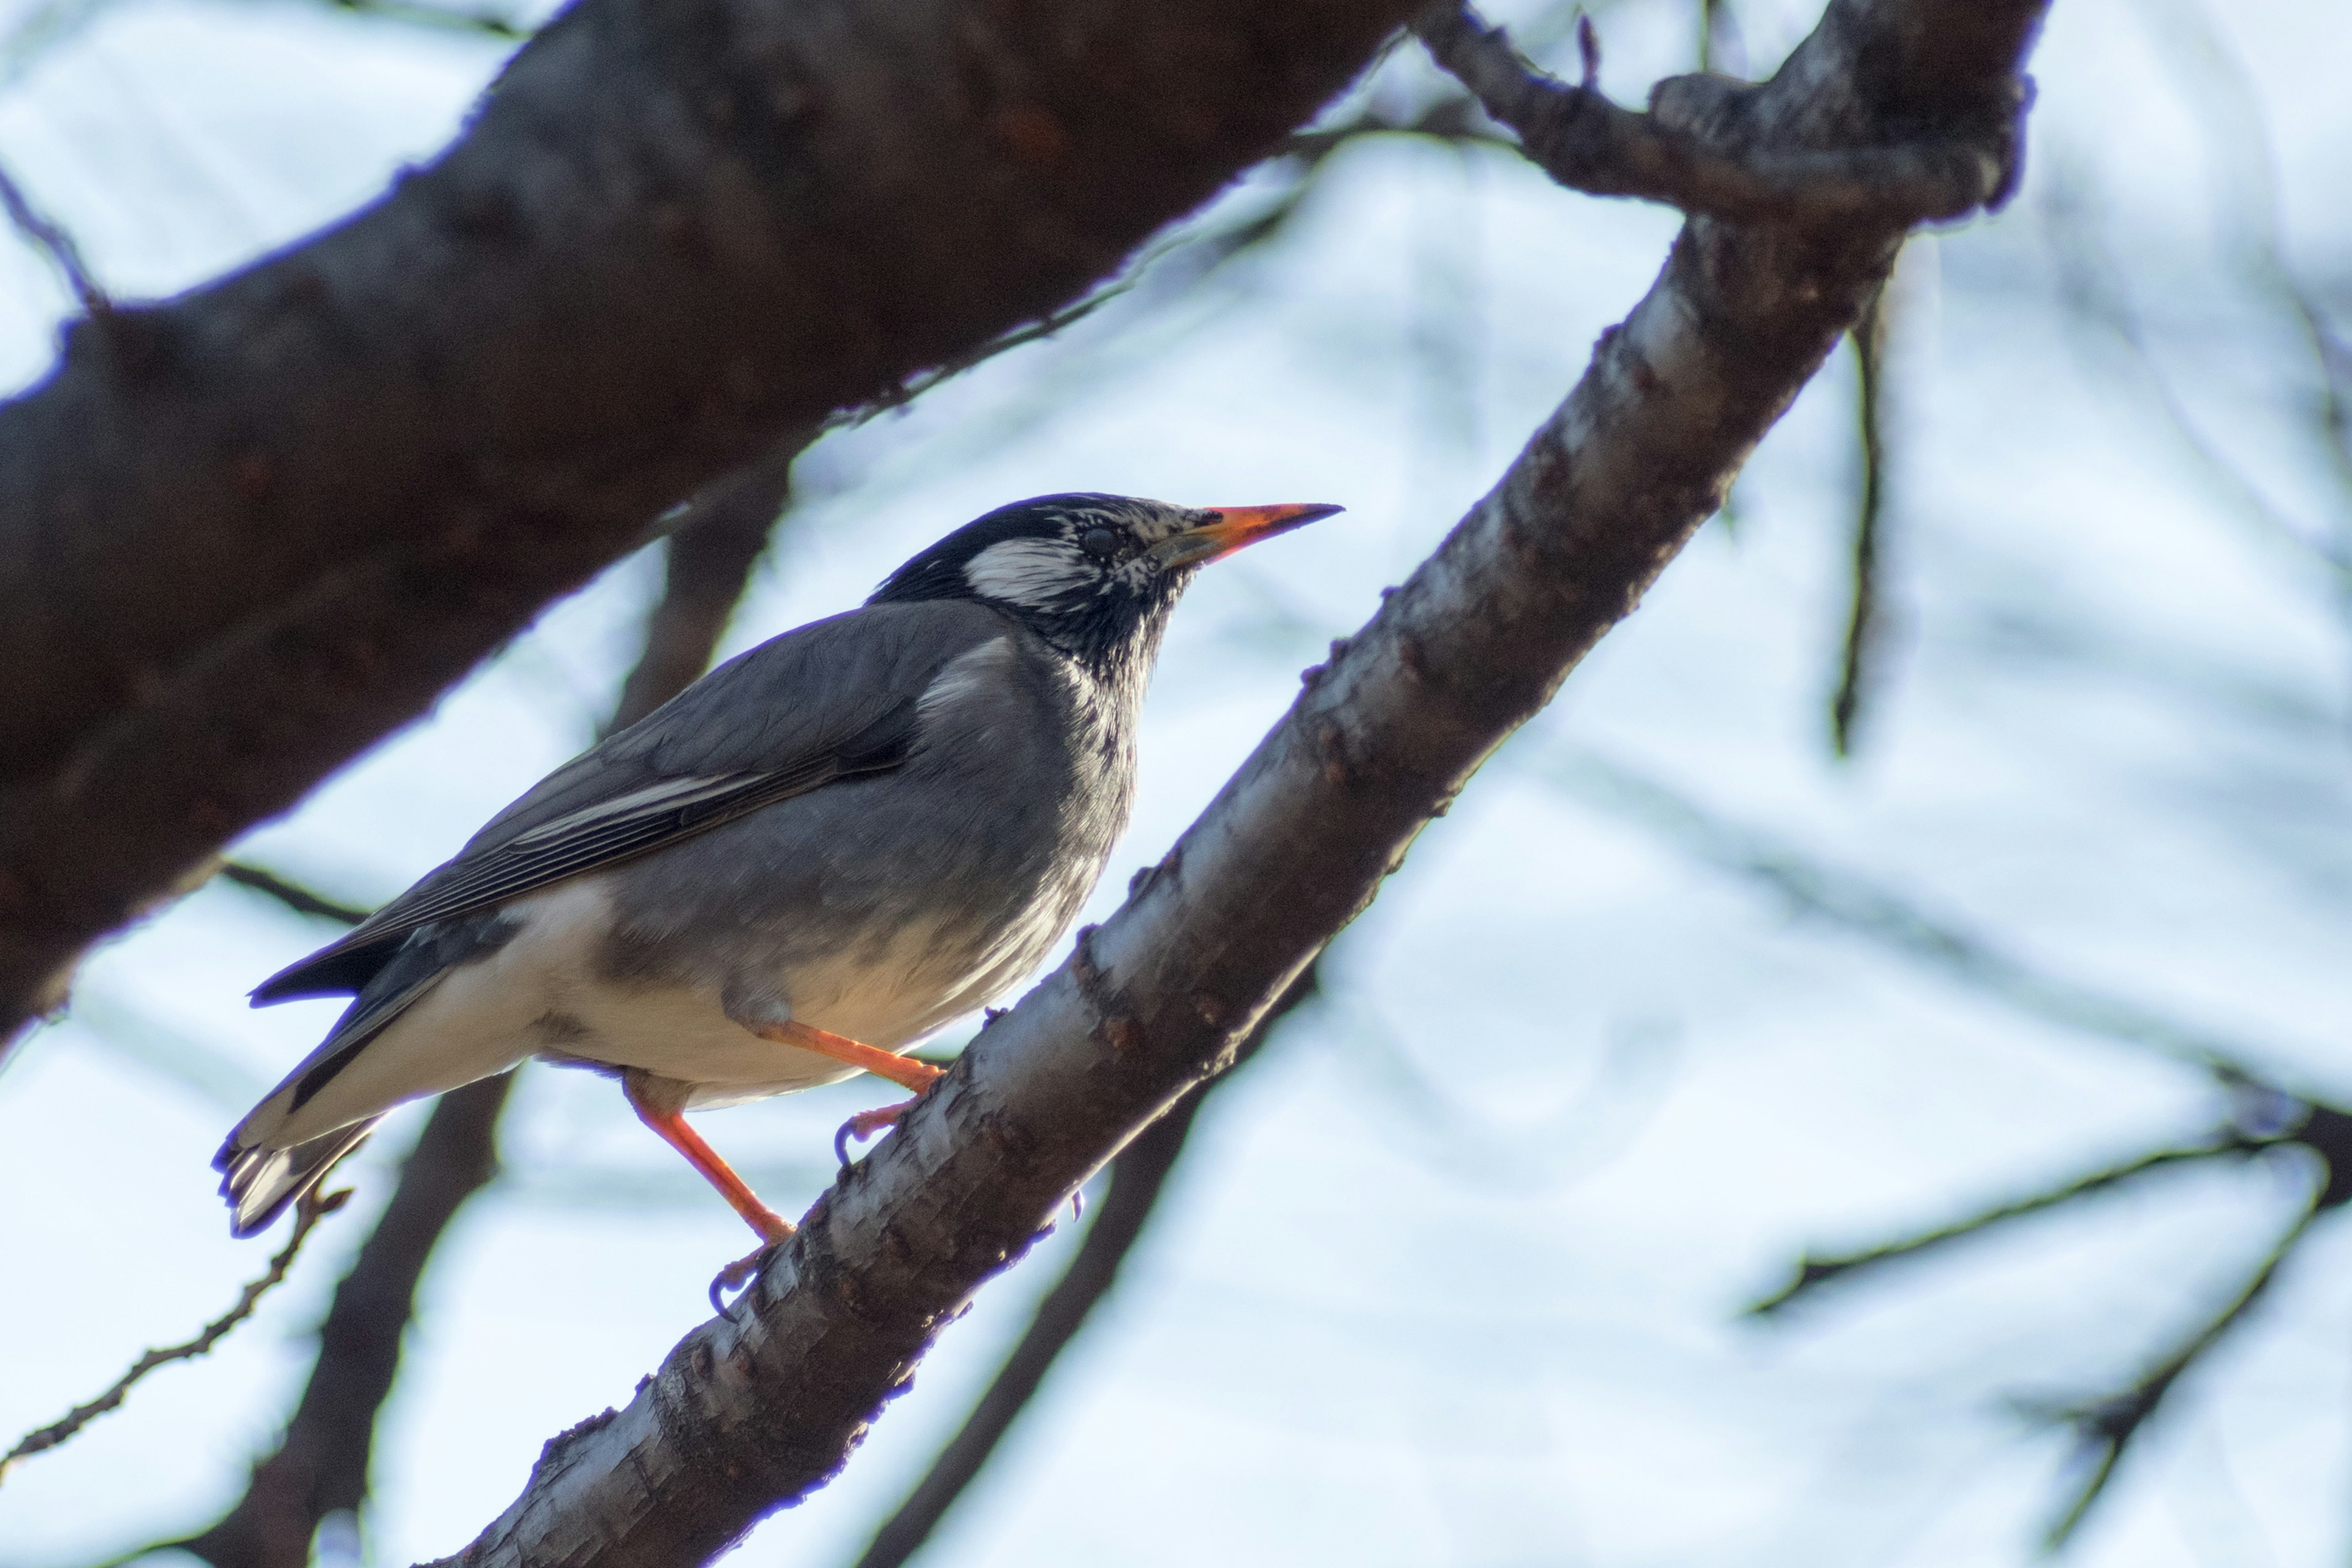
1414;0;2016;225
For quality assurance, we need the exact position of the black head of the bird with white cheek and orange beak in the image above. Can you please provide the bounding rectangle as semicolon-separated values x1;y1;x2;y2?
868;494;1341;668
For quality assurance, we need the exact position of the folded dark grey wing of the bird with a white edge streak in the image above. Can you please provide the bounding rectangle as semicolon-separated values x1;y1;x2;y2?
254;602;1009;1006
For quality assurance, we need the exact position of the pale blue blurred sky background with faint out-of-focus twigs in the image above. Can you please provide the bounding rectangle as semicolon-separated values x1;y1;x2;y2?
0;0;2352;1568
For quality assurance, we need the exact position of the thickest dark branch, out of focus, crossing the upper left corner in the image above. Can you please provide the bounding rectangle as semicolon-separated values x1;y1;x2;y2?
0;0;1409;1041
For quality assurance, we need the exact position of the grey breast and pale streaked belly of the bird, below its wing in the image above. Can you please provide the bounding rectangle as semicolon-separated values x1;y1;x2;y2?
600;620;1139;1049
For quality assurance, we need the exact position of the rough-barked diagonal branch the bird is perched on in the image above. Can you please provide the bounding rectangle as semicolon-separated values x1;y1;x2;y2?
432;0;2041;1568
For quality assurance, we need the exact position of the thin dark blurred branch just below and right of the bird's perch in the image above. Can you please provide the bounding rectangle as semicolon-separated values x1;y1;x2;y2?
856;964;1315;1568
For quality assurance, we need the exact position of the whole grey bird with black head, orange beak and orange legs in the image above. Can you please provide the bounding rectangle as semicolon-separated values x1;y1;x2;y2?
214;494;1343;1293
